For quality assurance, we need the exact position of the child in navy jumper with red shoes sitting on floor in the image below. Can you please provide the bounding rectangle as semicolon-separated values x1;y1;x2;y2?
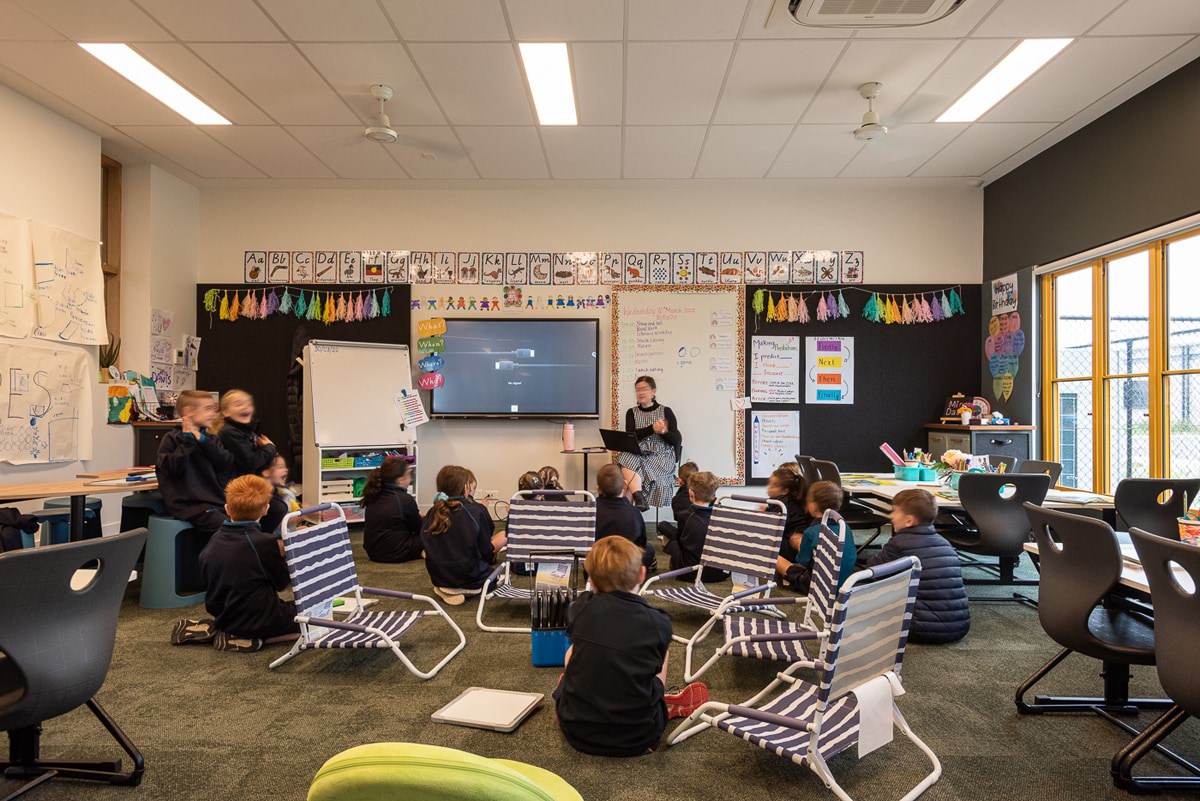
554;537;708;757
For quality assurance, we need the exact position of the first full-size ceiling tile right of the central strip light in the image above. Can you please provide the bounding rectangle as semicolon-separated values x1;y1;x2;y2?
625;42;733;125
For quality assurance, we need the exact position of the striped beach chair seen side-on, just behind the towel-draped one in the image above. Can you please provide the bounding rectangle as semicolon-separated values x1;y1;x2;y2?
688;510;848;681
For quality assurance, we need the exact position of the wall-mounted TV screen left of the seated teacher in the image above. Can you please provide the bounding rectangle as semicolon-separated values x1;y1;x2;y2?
432;319;600;417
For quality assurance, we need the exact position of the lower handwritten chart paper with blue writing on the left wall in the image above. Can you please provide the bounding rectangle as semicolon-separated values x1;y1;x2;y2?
0;345;95;464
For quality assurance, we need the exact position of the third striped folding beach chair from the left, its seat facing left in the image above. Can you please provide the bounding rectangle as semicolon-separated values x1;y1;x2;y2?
638;495;787;682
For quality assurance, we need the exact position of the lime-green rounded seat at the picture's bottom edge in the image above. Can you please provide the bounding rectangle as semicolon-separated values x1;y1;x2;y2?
308;742;583;801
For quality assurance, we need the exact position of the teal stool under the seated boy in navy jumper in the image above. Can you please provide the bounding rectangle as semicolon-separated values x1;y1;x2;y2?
138;514;208;609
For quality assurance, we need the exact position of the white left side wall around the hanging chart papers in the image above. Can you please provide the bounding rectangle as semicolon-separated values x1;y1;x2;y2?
0;86;133;531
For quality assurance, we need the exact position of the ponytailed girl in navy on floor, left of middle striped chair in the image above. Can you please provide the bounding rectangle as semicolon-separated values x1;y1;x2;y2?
421;464;508;607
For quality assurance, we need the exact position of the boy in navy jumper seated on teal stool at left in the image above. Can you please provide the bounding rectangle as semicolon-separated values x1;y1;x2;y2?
155;390;233;535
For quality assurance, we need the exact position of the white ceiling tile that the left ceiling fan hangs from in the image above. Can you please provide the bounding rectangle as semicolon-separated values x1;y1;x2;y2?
296;42;445;125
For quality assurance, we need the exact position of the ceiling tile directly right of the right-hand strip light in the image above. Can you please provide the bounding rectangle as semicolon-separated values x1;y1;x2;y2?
982;36;1190;122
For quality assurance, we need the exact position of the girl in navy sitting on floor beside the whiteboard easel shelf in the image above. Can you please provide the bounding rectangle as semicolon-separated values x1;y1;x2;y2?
362;457;421;562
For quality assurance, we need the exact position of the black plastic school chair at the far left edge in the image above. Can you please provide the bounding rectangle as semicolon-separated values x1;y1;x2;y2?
0;529;146;801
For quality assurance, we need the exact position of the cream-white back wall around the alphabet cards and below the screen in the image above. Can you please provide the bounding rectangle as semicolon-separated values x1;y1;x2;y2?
199;182;983;513
